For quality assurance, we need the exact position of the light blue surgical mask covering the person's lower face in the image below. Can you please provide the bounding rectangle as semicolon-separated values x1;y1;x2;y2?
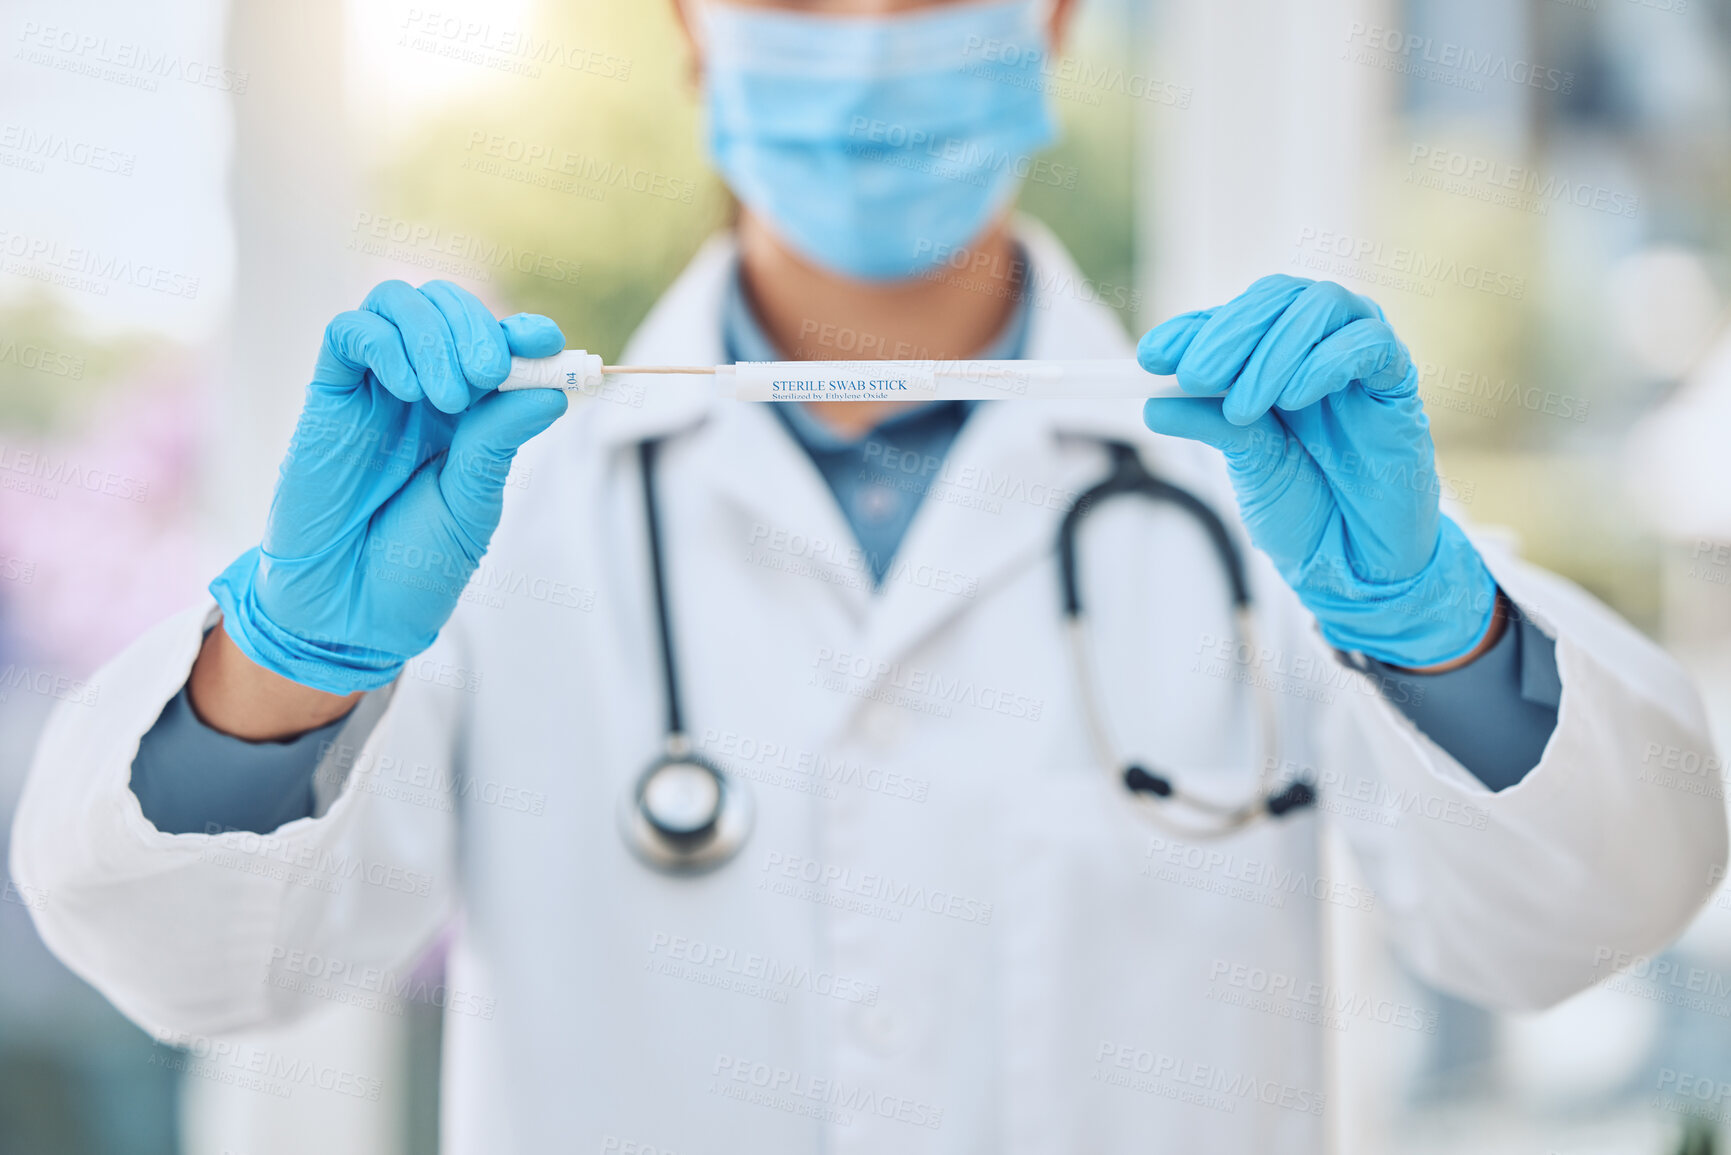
701;0;1058;281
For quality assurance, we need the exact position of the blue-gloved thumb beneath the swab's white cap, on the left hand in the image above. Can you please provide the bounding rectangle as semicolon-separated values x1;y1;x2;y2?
438;390;569;549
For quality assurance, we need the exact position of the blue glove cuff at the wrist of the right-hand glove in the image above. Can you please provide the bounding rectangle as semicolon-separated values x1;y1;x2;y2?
1281;516;1497;668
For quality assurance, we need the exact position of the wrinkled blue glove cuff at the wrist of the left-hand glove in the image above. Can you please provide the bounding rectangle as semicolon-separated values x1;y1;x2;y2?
209;547;424;694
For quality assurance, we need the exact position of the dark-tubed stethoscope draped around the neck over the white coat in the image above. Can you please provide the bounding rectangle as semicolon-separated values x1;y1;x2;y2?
620;438;1316;874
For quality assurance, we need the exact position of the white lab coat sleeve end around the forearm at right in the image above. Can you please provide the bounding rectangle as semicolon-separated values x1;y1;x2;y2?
1321;549;1726;1008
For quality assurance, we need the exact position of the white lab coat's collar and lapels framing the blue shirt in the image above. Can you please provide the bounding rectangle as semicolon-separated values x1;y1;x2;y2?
595;220;1170;658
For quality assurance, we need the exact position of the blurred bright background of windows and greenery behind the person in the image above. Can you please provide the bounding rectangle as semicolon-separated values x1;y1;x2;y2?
0;0;1731;1155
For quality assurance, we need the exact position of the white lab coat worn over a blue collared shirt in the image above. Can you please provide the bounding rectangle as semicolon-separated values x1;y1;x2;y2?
12;225;1726;1155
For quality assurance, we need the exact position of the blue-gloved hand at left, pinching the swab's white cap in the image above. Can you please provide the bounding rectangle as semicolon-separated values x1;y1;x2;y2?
211;281;566;694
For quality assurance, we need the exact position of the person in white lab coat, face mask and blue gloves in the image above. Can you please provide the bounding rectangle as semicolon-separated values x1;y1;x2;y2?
12;0;1726;1155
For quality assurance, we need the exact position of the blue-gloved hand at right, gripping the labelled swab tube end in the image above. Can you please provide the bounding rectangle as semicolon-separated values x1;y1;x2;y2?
1137;277;1497;667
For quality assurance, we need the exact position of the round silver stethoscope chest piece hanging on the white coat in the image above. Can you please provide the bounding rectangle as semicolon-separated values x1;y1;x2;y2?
620;736;753;874
